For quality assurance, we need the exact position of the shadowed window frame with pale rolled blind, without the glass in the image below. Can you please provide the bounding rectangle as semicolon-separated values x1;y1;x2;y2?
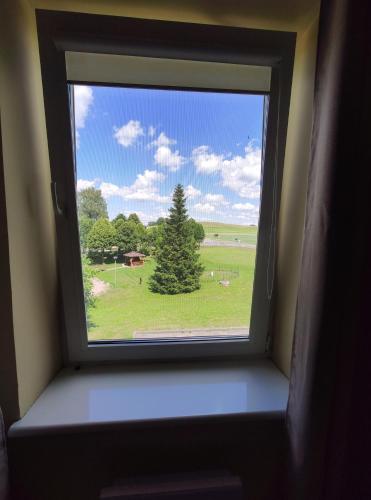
37;12;295;364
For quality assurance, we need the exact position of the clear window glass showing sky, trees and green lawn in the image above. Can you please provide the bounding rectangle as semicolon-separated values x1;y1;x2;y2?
71;85;264;341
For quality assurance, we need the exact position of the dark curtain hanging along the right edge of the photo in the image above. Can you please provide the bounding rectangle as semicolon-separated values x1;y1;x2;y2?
287;0;371;500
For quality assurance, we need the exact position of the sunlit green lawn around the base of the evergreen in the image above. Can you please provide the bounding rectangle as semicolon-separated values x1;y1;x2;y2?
89;246;255;340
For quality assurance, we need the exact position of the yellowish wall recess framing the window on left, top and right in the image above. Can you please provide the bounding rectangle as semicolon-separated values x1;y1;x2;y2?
0;0;318;415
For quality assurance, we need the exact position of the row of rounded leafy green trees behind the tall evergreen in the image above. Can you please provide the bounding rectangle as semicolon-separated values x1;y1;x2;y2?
77;187;205;263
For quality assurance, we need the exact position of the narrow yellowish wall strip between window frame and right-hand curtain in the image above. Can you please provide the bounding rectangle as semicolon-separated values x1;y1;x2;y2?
273;12;319;376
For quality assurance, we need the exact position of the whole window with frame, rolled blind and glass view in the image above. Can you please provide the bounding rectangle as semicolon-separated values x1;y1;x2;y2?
38;10;294;362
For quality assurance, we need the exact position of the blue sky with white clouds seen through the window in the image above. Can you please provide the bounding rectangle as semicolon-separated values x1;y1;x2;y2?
74;85;264;224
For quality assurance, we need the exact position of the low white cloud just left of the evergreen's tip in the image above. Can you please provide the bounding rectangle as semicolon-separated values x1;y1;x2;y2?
99;170;170;203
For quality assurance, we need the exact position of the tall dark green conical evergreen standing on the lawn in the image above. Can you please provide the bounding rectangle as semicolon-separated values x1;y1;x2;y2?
149;184;203;295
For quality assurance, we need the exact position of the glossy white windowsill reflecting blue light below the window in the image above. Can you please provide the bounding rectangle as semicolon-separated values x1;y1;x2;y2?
9;360;288;437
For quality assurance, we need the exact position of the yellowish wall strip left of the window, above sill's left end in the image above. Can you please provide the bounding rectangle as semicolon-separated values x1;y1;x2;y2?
0;0;61;416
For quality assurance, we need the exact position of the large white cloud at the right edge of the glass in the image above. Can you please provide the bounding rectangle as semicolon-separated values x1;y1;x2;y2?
192;143;261;199
